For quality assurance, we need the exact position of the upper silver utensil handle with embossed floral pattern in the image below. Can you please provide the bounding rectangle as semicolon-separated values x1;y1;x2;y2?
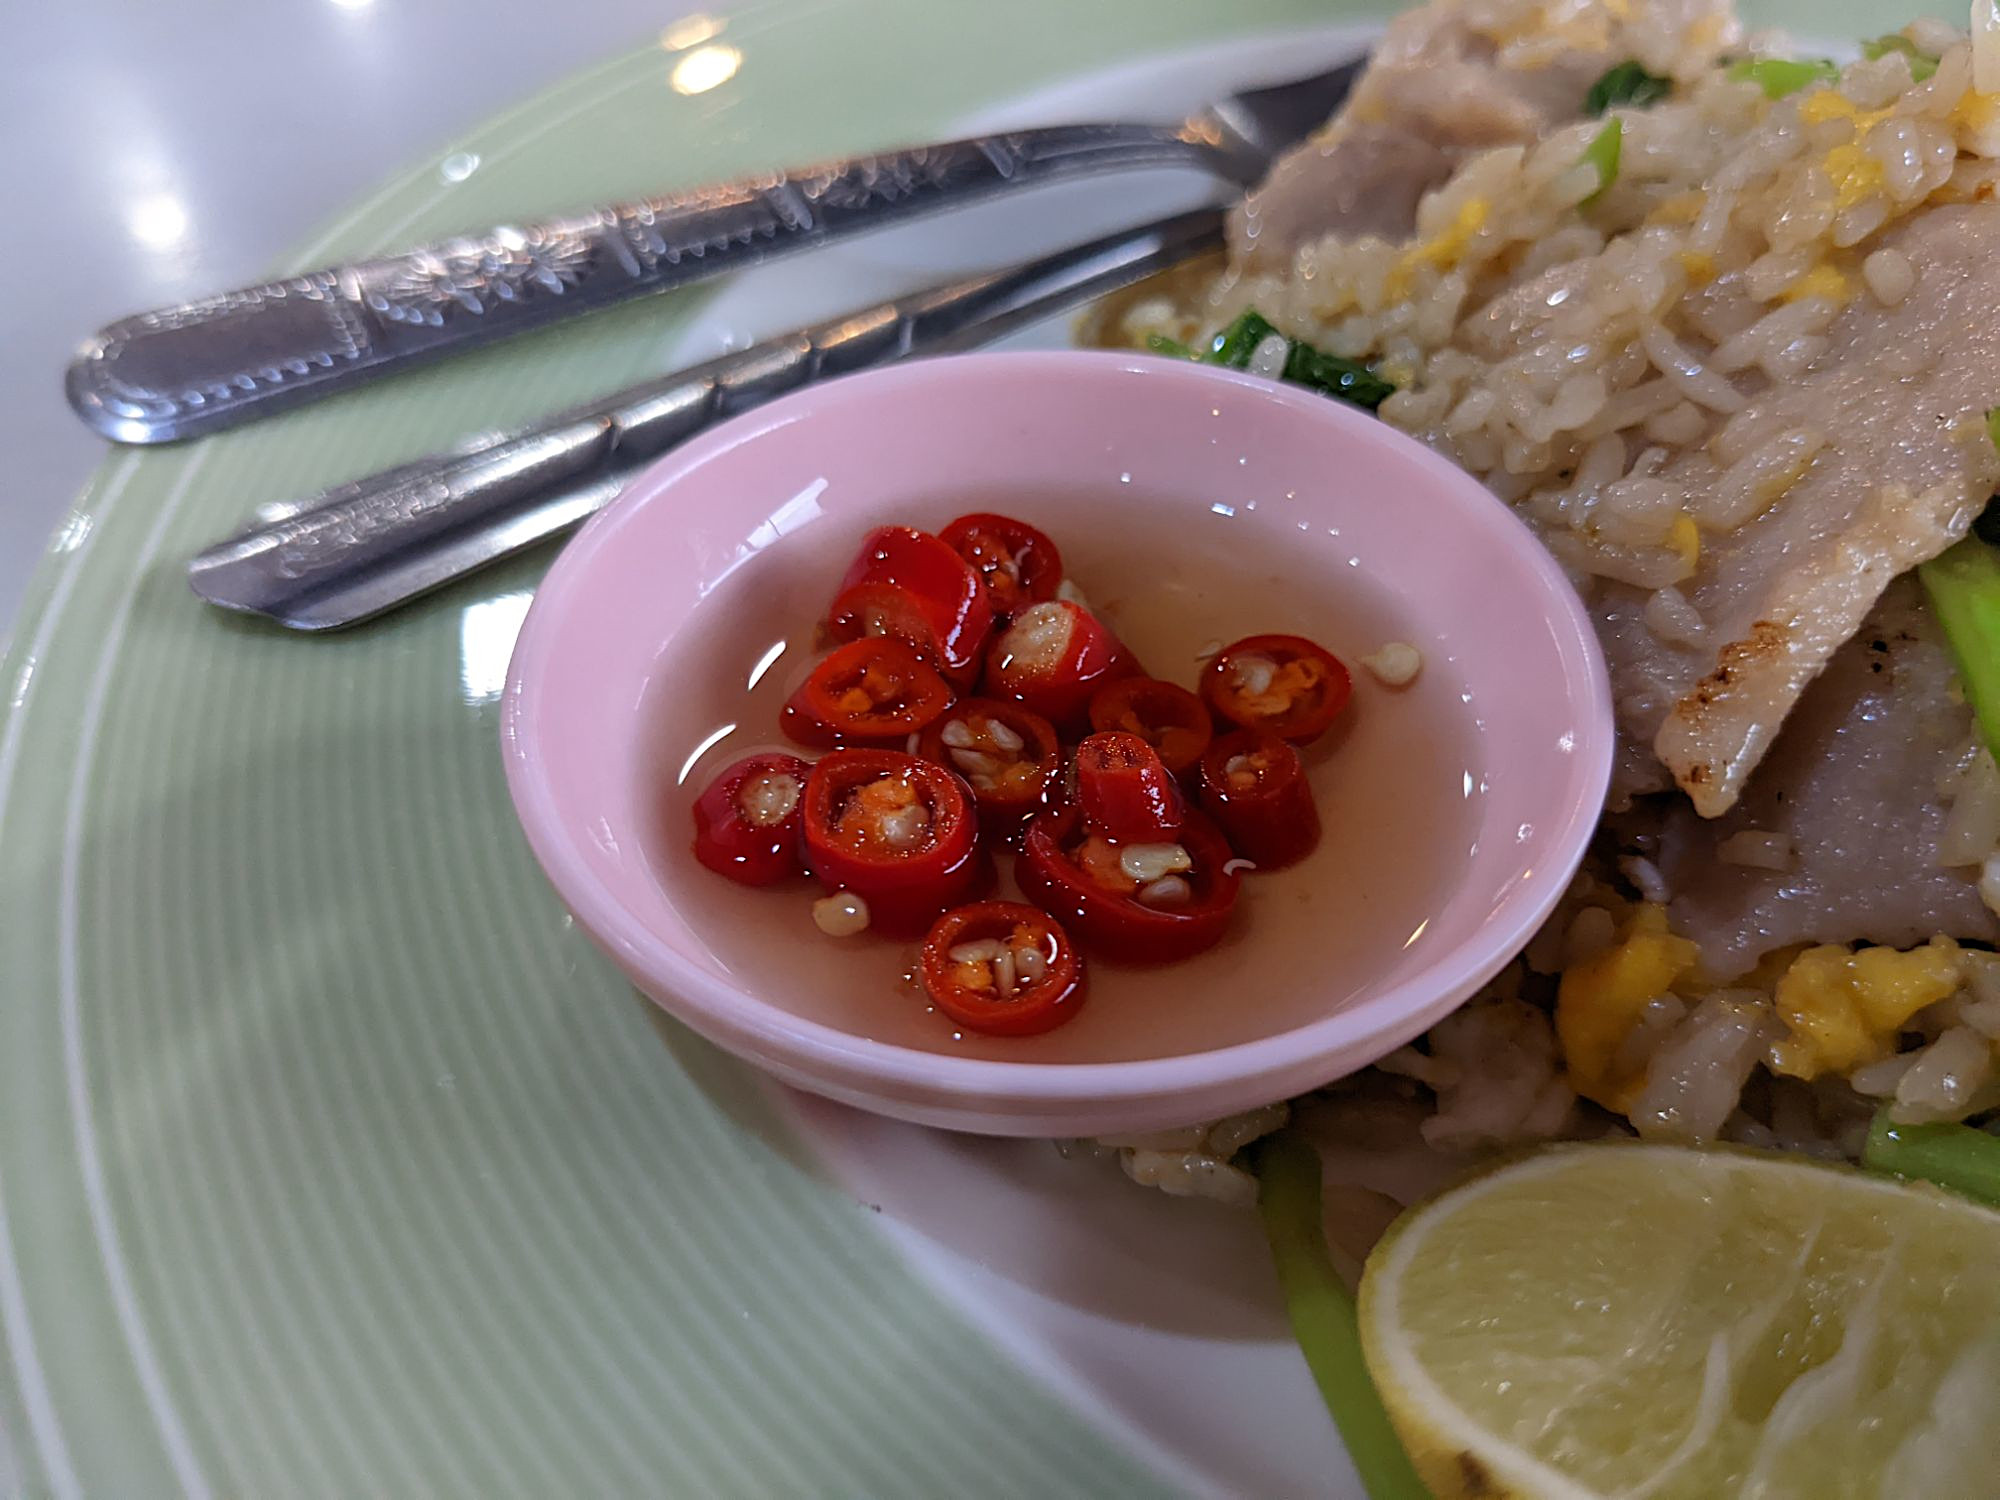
66;124;1240;444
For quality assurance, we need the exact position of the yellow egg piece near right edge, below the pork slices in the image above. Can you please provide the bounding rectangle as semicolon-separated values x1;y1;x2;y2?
1770;938;1958;1078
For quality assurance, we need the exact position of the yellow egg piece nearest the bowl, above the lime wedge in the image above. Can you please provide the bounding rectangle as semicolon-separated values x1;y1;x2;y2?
1556;902;1700;1112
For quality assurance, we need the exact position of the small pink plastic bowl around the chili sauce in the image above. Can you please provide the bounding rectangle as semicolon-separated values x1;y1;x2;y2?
502;354;1612;1136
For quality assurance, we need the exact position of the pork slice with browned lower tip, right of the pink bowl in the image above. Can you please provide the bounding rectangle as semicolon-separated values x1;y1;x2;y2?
1634;204;2000;816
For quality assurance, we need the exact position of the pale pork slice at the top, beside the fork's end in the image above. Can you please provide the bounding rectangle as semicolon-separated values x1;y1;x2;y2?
1230;0;1736;270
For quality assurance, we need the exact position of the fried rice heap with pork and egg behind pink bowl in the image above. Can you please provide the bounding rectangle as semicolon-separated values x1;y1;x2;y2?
1086;0;2000;1224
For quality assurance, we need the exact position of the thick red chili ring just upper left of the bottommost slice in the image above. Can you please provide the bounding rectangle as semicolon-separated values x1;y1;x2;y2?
804;750;990;936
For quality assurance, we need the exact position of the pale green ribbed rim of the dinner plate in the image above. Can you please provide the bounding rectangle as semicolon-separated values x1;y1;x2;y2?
0;0;1928;1500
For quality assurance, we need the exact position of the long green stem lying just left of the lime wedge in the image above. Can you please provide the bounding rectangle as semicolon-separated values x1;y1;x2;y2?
1250;1130;1430;1500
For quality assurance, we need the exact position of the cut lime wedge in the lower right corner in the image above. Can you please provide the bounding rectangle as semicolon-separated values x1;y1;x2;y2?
1360;1144;2000;1500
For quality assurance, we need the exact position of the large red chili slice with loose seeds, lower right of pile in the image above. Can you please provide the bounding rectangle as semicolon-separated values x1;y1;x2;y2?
1014;806;1242;964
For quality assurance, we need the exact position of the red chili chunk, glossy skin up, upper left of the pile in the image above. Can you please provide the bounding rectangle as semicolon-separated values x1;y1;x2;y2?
826;526;994;684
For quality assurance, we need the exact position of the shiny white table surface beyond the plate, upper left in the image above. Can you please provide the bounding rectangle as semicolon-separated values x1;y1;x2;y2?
0;0;728;642
